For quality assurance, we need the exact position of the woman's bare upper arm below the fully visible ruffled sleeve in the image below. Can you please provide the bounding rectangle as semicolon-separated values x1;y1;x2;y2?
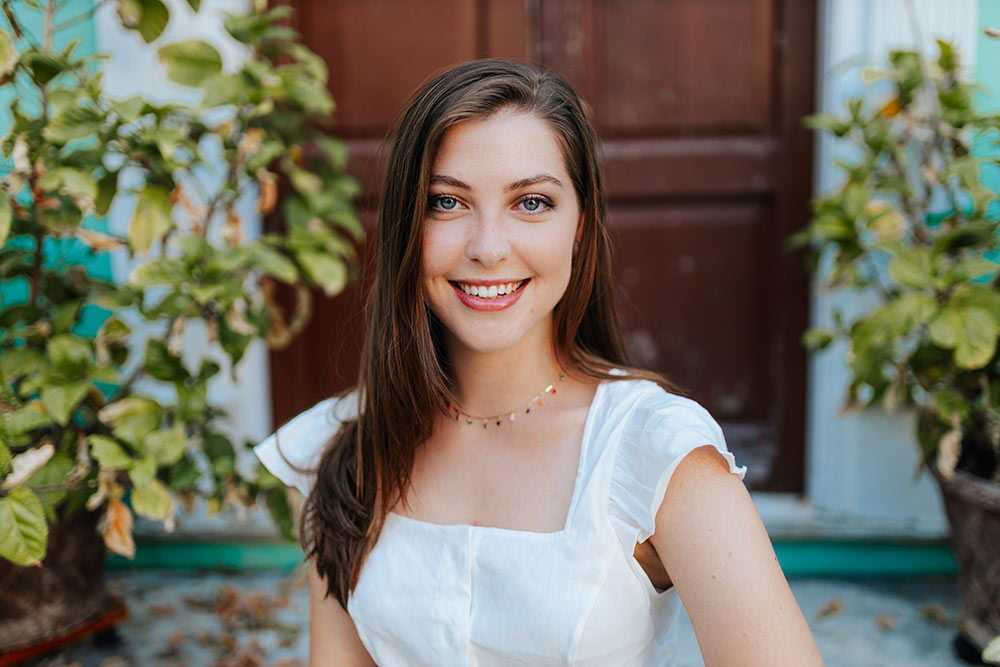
650;445;823;667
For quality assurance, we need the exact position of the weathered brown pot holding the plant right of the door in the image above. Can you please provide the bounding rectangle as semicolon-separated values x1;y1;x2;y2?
928;465;1000;651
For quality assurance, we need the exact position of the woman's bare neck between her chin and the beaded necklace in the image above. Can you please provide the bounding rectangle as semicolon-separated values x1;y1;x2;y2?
449;318;565;416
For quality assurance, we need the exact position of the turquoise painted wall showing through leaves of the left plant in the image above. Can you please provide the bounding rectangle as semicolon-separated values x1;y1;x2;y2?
0;0;112;336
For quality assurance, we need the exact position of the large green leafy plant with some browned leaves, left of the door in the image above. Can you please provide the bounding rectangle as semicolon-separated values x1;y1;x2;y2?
0;0;363;565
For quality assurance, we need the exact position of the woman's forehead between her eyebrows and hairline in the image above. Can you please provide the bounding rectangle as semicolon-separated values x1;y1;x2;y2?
432;110;570;185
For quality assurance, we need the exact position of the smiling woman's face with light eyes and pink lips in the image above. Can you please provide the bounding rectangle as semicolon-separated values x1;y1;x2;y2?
422;110;581;360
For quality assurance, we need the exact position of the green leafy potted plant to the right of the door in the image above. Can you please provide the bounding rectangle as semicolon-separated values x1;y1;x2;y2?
790;41;1000;481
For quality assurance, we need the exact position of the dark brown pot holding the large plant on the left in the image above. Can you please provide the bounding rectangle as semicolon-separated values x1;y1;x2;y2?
0;512;116;657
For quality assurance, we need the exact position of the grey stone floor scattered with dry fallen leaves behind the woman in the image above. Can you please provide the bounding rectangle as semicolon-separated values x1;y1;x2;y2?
19;571;966;667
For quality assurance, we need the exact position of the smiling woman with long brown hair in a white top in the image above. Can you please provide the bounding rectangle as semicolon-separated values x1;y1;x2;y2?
256;60;821;667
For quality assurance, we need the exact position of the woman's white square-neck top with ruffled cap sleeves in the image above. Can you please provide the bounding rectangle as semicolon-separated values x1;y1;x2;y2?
255;380;746;667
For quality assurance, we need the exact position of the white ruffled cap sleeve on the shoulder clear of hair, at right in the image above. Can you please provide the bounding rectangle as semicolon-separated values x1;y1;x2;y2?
608;387;747;548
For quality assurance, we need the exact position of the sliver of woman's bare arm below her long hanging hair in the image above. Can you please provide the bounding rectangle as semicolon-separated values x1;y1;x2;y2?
309;564;378;667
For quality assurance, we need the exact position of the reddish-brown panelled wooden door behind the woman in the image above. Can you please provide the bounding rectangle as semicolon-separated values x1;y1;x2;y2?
271;0;815;492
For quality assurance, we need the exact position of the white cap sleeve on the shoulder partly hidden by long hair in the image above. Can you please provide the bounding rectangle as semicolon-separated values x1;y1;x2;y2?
253;392;357;496
